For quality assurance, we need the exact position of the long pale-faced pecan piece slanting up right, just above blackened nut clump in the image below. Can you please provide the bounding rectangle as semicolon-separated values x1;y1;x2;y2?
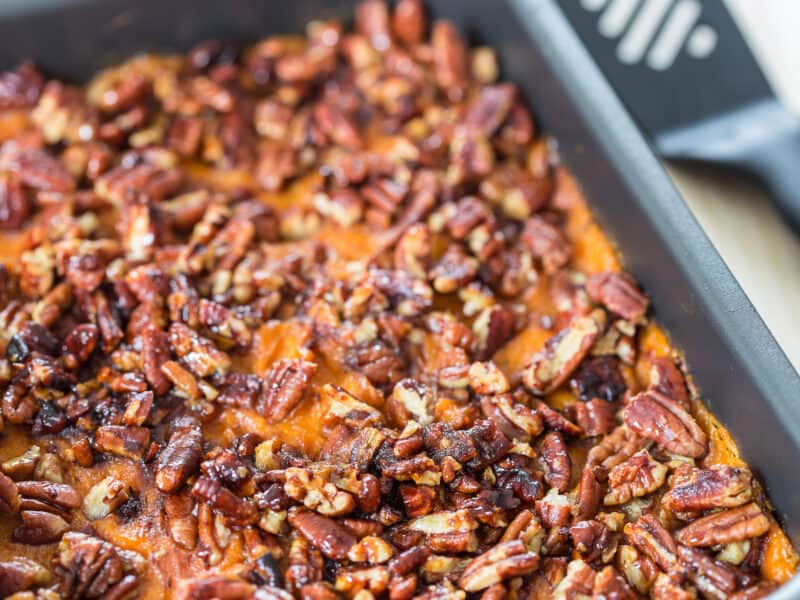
522;311;606;395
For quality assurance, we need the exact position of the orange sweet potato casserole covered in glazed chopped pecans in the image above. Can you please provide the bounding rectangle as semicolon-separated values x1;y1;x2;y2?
0;0;797;600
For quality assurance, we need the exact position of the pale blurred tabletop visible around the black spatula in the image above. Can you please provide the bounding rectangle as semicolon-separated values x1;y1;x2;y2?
667;0;800;371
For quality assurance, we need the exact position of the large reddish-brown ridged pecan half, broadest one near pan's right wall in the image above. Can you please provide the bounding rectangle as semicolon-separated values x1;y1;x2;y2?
623;391;707;458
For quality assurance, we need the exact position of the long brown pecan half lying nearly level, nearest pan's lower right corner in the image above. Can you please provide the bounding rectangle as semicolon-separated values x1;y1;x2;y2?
675;502;769;547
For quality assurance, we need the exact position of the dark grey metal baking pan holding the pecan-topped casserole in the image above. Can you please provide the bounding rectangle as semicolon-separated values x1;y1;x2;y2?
0;0;800;598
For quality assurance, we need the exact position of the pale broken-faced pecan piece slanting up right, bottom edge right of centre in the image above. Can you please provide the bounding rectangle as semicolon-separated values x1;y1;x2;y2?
458;540;539;592
